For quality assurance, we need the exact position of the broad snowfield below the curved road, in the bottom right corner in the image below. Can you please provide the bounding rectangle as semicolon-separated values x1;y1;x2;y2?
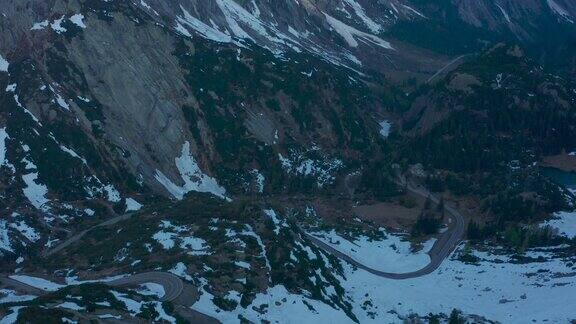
342;246;576;323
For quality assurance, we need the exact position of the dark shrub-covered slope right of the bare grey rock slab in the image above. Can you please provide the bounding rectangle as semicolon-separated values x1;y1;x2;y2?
173;39;394;196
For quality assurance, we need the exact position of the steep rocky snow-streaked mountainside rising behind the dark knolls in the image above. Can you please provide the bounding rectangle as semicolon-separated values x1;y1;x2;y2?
0;0;574;258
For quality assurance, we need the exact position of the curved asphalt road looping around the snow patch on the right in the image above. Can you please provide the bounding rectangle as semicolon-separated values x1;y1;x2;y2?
302;178;466;280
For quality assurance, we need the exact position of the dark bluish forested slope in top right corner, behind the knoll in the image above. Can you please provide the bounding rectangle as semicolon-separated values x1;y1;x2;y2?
386;0;576;77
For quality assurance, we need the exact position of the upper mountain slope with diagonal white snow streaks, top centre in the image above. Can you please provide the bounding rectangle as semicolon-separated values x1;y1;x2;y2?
140;0;418;68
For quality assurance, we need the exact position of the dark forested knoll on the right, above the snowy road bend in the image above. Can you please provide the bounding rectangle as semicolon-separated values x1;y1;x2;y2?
396;45;576;249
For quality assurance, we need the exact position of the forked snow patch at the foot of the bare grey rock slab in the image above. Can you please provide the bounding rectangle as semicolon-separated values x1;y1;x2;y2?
156;141;228;200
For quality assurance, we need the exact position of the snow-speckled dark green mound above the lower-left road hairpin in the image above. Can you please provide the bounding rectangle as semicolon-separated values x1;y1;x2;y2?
39;193;364;319
